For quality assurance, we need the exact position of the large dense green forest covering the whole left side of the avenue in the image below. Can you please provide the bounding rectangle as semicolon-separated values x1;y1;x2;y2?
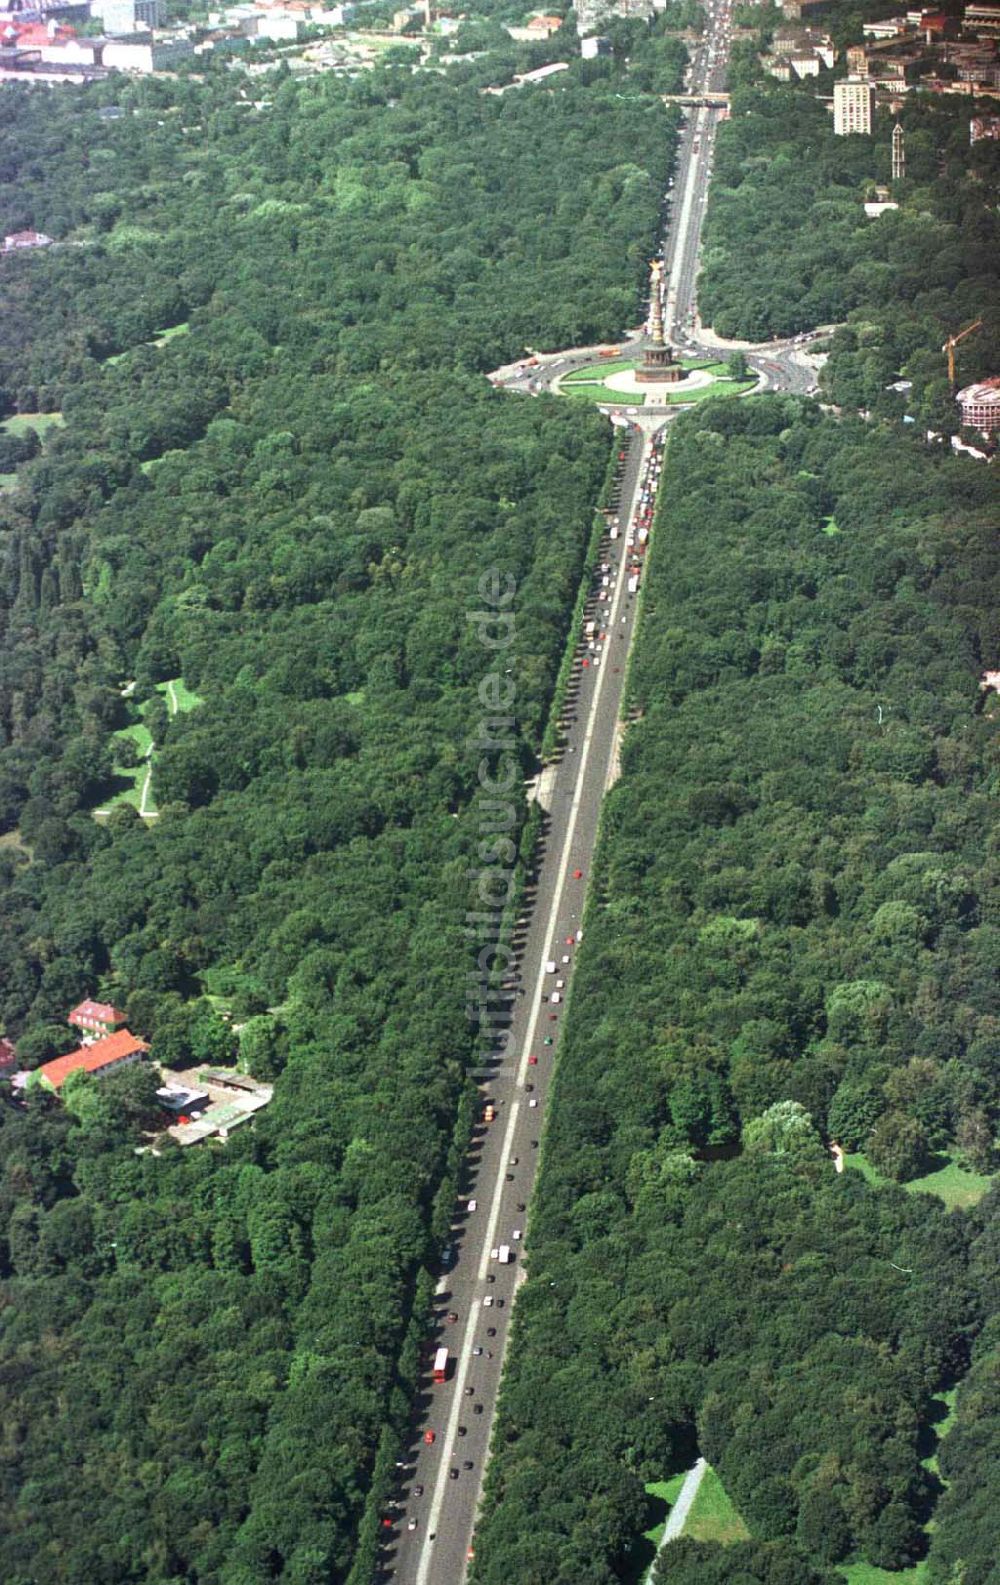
0;35;683;1585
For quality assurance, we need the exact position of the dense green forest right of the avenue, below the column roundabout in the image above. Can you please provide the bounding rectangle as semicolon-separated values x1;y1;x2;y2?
475;398;1000;1585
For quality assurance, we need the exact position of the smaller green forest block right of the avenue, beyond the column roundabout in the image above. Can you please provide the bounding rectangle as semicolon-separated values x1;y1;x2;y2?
699;55;1000;431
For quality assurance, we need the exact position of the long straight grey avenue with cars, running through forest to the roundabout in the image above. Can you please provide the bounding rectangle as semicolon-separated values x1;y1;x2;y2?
380;10;738;1585
